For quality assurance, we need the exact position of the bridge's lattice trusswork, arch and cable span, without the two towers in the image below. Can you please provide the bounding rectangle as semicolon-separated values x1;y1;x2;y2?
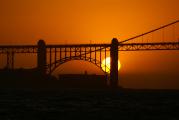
0;20;179;74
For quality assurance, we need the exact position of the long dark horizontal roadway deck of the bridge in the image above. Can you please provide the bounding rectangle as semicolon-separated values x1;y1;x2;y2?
0;42;179;54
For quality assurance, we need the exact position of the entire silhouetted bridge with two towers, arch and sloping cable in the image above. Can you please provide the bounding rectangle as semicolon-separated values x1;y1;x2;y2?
0;20;179;88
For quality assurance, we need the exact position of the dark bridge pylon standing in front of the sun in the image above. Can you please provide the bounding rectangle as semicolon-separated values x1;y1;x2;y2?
110;38;119;88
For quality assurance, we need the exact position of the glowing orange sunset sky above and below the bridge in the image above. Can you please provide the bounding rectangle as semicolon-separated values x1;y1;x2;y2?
0;0;179;88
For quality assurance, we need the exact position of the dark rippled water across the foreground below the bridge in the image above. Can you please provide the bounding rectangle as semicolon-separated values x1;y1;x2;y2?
0;89;179;120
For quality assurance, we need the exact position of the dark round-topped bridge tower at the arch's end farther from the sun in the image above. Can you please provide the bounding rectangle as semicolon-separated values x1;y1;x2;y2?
37;40;47;76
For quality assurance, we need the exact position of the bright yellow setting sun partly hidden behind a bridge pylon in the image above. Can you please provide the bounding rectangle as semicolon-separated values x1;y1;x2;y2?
101;57;121;73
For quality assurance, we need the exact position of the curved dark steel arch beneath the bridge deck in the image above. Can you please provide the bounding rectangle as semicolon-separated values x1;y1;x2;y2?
47;56;110;75
